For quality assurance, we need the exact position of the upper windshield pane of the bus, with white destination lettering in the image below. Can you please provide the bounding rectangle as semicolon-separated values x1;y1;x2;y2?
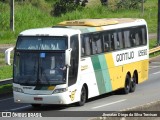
16;36;67;50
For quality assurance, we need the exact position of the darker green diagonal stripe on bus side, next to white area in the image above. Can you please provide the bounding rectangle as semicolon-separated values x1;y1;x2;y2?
91;56;106;94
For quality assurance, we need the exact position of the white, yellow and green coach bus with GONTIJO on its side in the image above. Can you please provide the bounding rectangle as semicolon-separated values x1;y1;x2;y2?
8;18;149;107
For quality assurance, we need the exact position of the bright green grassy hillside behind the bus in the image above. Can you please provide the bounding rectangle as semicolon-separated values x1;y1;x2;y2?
0;0;158;44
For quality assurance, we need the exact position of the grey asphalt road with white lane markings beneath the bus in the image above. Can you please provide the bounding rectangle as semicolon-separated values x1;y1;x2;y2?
0;57;160;119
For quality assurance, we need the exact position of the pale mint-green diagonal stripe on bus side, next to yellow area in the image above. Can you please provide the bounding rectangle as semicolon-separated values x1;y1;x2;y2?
98;55;112;92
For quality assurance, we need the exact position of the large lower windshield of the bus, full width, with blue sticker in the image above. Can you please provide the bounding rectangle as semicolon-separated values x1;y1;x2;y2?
14;52;66;85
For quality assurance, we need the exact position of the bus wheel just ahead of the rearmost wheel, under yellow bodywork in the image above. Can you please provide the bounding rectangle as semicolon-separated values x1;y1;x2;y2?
123;74;131;94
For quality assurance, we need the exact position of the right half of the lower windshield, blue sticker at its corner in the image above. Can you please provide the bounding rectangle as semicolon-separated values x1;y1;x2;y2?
40;53;65;83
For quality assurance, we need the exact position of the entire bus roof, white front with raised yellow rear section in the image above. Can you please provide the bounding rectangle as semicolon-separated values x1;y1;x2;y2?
20;18;146;36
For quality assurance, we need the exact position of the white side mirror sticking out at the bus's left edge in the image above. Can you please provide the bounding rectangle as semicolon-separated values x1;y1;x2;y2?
5;47;14;65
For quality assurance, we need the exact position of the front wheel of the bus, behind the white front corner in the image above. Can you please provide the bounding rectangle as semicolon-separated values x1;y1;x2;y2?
77;86;87;106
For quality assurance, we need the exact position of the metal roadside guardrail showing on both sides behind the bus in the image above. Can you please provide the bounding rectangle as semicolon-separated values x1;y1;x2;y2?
0;46;160;86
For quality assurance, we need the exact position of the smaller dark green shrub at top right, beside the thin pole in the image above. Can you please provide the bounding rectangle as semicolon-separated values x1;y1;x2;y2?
116;0;146;9
